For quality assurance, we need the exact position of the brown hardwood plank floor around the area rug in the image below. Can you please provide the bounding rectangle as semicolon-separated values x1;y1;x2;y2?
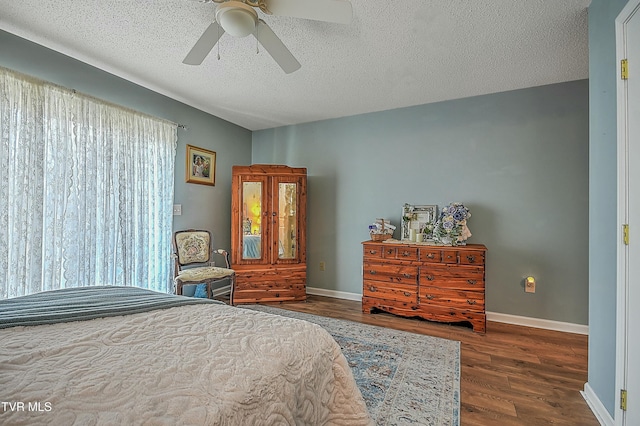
249;295;599;426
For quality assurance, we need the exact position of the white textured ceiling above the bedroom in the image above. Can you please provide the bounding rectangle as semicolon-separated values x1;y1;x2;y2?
0;0;590;130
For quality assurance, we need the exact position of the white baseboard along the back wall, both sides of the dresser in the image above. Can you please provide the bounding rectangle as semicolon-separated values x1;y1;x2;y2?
307;287;589;334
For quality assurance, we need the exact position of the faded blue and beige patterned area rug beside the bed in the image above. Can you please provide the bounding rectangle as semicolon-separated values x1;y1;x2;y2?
242;305;460;426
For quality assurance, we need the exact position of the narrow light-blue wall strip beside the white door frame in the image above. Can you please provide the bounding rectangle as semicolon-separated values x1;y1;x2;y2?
589;0;627;416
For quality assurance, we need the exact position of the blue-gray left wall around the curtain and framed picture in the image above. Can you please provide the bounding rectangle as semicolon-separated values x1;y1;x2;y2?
0;30;251;256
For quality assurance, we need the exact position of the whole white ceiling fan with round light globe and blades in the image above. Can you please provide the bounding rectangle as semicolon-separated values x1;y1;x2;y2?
182;0;353;74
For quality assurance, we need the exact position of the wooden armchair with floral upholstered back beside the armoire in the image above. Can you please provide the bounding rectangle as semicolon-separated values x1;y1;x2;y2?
173;229;236;305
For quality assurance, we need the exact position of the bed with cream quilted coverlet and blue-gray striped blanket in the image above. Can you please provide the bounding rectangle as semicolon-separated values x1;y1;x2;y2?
0;287;372;425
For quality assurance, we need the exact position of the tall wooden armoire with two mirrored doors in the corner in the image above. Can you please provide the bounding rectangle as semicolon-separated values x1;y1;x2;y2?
231;164;307;304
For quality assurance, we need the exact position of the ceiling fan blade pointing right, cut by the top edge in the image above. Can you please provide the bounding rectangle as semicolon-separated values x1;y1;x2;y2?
266;0;353;24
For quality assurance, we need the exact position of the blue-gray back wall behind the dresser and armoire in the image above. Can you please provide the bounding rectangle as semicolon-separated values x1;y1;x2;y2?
253;80;589;324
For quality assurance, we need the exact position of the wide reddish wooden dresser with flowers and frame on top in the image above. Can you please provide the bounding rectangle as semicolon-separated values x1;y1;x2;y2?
362;241;487;333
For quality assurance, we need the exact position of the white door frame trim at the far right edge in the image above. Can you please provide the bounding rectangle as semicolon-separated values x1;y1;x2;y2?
614;0;640;426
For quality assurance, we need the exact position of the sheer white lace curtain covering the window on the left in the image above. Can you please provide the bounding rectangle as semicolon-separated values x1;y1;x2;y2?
0;68;177;298
